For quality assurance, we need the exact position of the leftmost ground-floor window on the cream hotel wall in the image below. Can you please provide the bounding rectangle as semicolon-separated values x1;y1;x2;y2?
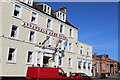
7;48;16;62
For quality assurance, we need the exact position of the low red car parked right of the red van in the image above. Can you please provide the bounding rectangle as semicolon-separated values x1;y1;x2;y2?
69;73;92;80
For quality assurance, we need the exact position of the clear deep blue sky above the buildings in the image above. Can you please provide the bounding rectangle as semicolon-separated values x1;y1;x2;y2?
36;2;118;60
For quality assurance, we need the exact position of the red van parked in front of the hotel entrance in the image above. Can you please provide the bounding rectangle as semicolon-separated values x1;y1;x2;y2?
26;67;68;80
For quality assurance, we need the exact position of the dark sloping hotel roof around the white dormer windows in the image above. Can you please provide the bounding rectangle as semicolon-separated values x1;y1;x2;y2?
33;1;79;30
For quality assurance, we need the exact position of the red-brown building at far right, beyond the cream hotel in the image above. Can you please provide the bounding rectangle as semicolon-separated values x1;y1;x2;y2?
93;54;118;76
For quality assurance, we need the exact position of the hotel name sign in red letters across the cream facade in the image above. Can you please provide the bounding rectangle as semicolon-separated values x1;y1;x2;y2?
22;22;67;40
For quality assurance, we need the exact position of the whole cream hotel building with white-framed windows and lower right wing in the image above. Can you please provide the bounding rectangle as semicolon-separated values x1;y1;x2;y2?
0;0;92;78
